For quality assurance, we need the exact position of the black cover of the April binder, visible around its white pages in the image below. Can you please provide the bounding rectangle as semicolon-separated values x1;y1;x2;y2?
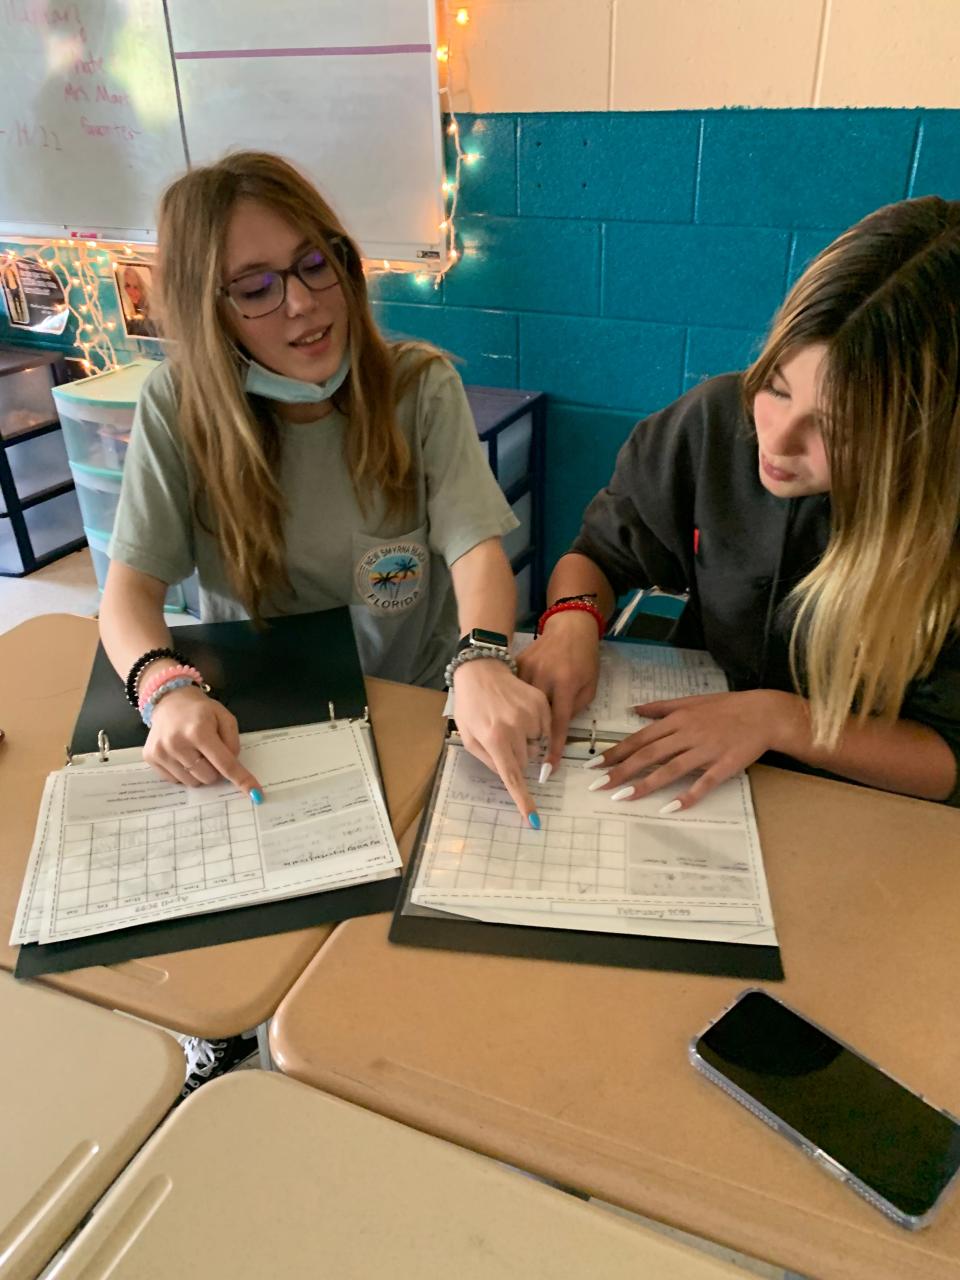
15;608;401;978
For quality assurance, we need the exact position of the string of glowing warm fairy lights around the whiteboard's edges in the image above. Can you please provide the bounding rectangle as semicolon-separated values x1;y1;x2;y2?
0;8;480;374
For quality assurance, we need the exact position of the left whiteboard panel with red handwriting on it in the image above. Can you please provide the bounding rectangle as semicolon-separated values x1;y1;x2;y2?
0;0;184;239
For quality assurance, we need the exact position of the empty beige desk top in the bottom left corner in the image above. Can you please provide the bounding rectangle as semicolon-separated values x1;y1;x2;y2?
0;974;183;1280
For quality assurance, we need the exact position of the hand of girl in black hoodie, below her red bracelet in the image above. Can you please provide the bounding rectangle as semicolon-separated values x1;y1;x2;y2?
517;609;600;768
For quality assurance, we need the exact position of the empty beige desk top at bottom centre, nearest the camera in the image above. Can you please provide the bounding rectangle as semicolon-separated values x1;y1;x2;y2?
47;1071;742;1280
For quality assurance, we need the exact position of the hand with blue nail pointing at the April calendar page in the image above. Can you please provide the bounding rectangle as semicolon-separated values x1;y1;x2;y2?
143;685;261;804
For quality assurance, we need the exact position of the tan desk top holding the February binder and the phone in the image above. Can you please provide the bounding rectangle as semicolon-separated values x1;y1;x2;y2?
271;767;960;1280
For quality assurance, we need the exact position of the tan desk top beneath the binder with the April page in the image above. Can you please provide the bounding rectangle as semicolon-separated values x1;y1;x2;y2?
0;614;443;1037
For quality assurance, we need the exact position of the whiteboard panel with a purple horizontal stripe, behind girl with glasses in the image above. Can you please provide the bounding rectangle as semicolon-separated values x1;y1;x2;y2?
168;0;445;265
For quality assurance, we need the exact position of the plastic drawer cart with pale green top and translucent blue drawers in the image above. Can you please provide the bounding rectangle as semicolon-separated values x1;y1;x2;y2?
54;360;197;613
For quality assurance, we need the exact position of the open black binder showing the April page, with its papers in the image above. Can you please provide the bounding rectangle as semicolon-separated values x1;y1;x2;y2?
12;609;399;977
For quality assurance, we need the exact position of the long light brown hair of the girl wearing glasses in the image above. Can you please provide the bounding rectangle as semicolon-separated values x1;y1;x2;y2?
159;151;440;620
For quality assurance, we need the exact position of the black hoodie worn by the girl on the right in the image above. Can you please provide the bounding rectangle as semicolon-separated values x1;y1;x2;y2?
571;374;960;806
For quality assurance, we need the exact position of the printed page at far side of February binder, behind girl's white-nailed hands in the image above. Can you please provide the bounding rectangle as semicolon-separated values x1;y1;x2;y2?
513;632;730;737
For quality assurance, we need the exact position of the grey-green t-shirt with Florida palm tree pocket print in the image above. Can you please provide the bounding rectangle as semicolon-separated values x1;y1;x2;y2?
110;350;517;687
